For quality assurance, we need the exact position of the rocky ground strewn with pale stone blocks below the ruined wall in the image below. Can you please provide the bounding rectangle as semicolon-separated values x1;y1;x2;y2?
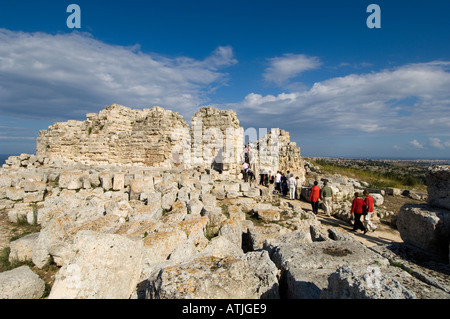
0;160;450;299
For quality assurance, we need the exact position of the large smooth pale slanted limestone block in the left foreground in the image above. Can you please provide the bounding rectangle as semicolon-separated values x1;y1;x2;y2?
49;231;143;299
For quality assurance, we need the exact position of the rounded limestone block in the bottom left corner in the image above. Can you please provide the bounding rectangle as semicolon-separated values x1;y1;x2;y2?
0;266;45;299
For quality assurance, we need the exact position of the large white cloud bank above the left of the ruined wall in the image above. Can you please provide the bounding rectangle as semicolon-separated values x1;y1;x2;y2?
0;29;237;118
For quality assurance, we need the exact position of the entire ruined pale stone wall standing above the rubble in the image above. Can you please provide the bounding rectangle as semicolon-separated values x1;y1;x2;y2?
36;104;304;179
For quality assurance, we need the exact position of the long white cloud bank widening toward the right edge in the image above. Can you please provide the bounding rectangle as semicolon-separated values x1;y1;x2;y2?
238;61;450;136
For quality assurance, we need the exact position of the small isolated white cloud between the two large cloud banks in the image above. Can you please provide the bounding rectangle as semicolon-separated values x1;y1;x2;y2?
263;54;322;85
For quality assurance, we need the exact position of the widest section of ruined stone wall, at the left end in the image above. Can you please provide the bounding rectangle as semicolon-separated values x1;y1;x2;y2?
36;104;189;167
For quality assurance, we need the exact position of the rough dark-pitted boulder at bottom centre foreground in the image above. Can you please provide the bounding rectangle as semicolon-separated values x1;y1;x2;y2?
150;252;279;299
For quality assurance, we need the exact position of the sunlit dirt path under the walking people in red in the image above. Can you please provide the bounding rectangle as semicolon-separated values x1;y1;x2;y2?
281;199;403;247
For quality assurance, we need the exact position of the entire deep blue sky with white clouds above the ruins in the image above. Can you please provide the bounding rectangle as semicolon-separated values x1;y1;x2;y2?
0;0;450;159
